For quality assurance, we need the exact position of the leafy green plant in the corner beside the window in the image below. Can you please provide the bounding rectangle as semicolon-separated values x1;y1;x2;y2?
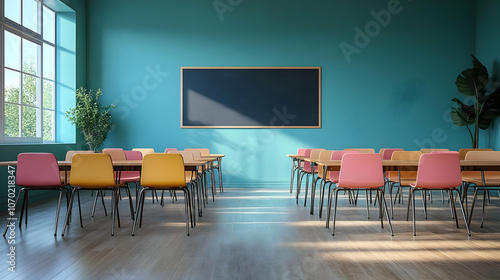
66;87;115;152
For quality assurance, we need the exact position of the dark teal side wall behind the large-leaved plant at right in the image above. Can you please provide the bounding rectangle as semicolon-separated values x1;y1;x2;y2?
475;0;500;150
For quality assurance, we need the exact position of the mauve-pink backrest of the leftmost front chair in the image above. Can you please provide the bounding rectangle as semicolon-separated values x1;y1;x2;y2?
16;153;61;188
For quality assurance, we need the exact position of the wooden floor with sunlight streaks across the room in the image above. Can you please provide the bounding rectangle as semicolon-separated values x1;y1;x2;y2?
0;187;500;279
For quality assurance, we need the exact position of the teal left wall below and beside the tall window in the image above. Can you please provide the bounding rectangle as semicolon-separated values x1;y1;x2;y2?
0;0;86;212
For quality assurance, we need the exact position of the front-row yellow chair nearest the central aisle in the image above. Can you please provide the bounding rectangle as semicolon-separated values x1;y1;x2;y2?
132;153;193;236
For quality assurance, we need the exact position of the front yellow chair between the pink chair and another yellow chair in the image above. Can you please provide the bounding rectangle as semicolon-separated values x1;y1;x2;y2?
62;153;120;236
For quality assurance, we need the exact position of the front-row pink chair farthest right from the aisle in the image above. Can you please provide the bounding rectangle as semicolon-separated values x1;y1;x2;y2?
406;152;470;236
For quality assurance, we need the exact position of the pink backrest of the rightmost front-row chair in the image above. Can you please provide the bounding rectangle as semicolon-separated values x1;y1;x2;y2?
416;152;462;189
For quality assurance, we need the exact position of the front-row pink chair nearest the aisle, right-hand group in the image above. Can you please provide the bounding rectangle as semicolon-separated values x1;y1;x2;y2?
332;153;394;236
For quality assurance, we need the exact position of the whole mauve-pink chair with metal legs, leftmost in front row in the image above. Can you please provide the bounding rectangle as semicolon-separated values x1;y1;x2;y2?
3;153;68;237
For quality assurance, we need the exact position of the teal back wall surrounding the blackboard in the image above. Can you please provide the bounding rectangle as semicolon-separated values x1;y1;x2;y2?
87;0;475;186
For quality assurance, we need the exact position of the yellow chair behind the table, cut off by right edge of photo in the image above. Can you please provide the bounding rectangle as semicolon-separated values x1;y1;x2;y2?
462;151;500;228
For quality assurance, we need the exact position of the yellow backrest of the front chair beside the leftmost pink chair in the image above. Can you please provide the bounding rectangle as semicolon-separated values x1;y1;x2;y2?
70;153;115;188
